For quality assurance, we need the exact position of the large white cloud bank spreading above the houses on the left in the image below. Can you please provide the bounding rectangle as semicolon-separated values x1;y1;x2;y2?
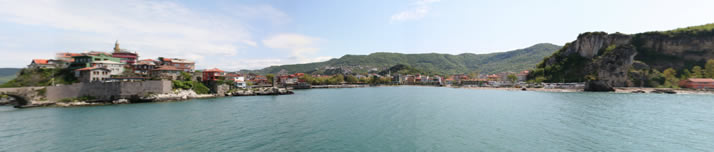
0;0;289;65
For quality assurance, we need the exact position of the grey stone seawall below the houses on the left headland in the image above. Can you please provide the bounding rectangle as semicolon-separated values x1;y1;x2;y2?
47;80;172;101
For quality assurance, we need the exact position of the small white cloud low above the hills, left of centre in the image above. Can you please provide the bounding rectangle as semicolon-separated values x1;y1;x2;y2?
263;34;325;63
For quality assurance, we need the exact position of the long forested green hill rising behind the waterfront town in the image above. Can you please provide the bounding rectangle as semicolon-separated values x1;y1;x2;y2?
248;43;561;74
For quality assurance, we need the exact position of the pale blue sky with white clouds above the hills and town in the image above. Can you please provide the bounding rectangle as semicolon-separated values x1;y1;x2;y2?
0;0;714;70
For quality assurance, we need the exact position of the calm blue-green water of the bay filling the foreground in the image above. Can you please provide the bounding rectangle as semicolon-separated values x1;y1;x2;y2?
0;87;714;152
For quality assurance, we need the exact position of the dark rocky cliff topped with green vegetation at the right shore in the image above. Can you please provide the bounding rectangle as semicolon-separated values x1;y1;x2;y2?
529;24;714;91
